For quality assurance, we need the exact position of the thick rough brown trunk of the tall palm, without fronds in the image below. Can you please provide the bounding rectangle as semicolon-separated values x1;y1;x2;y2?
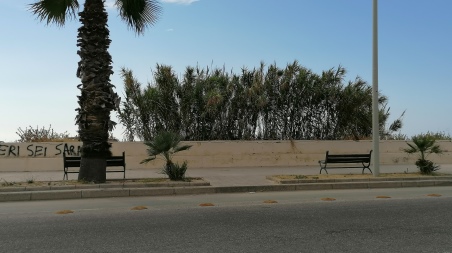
76;0;119;183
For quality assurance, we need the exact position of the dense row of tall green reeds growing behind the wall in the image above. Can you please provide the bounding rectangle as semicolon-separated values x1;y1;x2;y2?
119;62;402;141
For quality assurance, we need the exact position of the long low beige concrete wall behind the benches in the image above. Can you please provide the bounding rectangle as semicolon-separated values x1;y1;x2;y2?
0;141;452;172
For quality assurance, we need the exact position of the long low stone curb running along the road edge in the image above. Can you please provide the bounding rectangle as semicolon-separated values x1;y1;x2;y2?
0;179;452;202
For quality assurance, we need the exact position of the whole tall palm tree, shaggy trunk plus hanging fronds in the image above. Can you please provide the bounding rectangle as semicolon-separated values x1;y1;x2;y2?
30;0;161;182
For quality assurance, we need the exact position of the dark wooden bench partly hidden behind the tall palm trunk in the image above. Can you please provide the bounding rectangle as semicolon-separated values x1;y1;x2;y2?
63;152;126;180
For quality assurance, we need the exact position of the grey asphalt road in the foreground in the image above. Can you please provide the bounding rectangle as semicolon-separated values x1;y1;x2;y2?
0;187;452;253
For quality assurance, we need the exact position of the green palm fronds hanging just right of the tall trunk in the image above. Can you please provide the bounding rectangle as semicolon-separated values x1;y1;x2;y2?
116;0;161;34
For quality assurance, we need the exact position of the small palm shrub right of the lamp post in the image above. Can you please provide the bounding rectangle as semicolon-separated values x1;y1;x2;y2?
404;133;443;174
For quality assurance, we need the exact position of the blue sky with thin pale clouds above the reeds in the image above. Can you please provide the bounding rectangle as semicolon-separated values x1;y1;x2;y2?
0;0;452;142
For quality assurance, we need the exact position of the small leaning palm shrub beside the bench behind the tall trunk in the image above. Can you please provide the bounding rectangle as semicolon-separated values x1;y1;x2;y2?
141;131;191;180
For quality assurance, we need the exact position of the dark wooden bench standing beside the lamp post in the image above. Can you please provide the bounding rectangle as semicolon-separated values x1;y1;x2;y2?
319;150;372;174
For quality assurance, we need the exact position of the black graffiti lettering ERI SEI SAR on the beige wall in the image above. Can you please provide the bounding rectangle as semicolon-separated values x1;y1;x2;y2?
0;143;81;158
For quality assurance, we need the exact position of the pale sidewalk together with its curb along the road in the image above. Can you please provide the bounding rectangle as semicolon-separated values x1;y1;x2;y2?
0;164;452;202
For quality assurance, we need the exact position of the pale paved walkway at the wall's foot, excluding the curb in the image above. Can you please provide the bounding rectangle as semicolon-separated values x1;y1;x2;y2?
0;164;452;187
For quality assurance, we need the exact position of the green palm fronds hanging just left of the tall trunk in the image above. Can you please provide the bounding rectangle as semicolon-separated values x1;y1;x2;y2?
29;0;79;26
